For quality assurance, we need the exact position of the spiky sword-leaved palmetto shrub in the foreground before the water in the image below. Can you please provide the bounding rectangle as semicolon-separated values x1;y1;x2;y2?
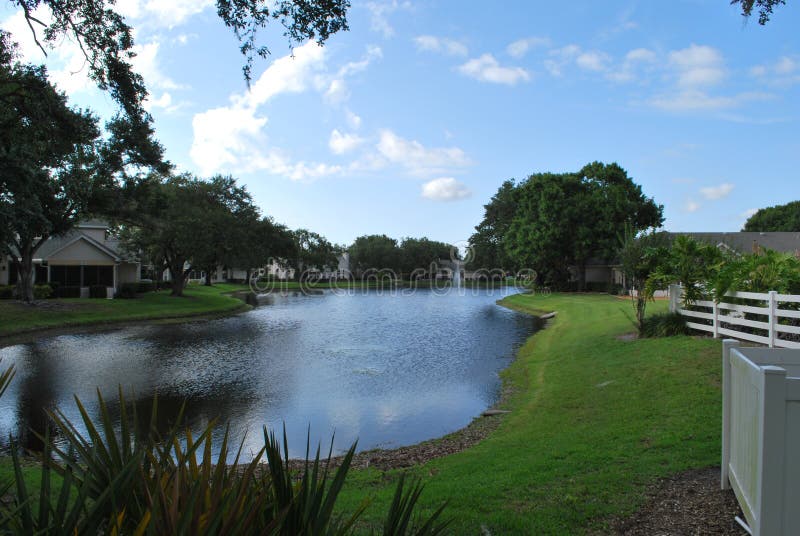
0;390;447;536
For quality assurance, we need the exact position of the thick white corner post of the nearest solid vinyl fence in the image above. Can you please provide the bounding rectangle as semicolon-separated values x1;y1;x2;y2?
751;366;789;536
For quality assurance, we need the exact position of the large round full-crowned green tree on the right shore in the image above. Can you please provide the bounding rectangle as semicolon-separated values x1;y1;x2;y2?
503;162;663;290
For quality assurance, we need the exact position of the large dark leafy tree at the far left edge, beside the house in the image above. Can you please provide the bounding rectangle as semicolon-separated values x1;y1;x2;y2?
0;40;103;302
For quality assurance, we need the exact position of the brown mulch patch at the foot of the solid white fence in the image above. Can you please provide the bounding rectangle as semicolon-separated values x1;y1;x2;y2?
593;467;747;536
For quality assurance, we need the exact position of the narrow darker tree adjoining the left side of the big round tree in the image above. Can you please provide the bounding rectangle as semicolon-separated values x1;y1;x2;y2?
469;179;519;270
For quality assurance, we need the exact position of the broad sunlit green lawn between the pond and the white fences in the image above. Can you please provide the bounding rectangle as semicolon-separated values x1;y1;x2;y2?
338;295;721;534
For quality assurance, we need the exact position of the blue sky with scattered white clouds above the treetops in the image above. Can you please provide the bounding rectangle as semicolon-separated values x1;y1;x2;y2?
0;0;800;243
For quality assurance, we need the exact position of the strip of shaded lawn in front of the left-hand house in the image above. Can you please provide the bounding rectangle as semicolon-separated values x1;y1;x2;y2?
0;284;247;337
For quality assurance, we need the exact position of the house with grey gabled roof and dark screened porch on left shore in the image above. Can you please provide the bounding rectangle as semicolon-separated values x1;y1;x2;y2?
0;220;140;297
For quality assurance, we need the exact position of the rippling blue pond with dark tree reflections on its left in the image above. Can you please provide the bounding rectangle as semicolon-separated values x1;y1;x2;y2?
0;289;535;456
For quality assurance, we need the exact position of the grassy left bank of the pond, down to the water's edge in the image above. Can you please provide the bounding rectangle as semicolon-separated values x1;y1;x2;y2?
0;284;251;348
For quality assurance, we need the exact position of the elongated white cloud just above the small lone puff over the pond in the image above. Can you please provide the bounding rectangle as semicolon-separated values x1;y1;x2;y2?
376;129;472;176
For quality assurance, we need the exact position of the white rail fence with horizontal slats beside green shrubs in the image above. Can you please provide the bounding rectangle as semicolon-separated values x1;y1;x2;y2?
669;285;800;348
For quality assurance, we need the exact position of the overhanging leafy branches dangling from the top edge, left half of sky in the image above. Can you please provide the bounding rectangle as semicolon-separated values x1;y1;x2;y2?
11;0;350;118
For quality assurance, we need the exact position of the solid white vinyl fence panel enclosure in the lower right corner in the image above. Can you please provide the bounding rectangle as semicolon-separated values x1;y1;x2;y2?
721;340;800;536
